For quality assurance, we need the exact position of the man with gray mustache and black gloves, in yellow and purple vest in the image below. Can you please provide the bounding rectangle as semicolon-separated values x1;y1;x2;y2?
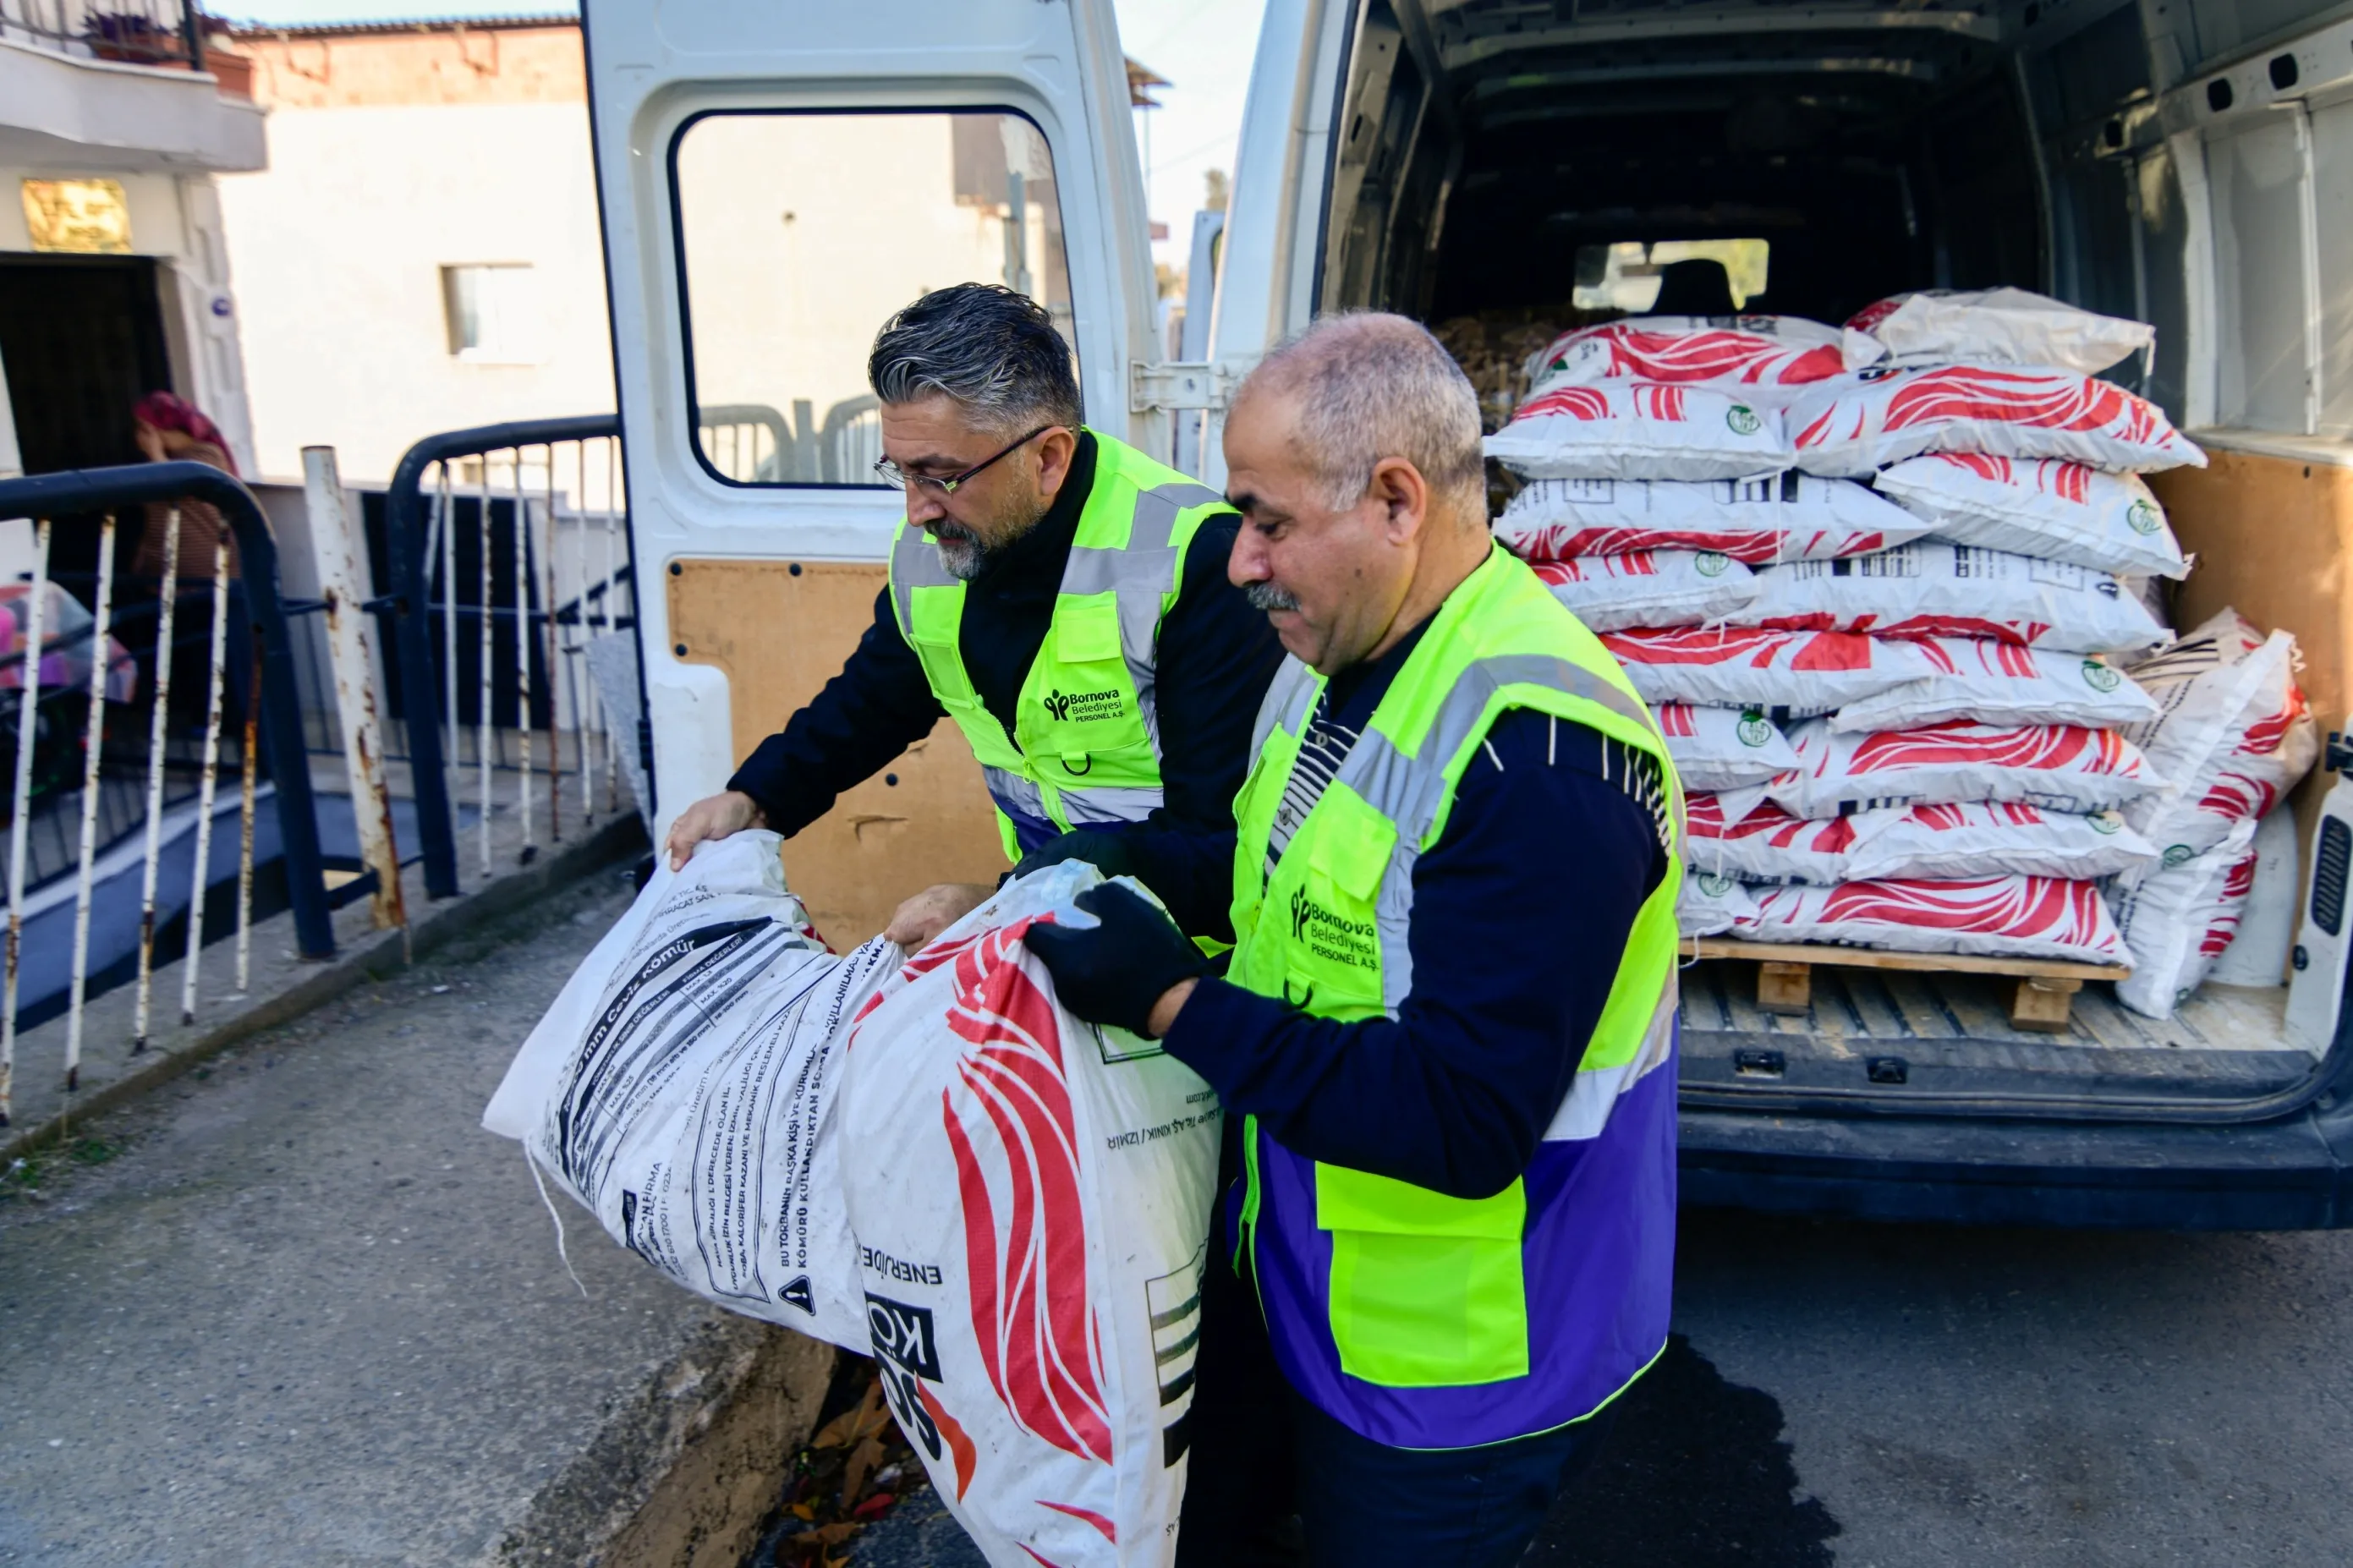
1023;315;1682;1568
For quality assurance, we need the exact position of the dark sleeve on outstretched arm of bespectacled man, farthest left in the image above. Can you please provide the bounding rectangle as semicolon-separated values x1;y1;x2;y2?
727;586;946;838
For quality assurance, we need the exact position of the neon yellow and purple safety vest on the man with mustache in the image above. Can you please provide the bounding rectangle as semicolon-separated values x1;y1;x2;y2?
1228;551;1682;1448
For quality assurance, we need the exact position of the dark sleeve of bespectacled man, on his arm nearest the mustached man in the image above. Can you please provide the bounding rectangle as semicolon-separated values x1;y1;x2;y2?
1125;513;1282;940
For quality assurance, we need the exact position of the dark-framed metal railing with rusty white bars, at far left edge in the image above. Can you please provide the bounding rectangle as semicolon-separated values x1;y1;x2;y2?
0;462;334;1126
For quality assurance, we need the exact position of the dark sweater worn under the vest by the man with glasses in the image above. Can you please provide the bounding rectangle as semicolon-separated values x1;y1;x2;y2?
727;433;1282;937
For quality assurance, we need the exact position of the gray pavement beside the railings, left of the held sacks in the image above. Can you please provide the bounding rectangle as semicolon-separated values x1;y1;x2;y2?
0;869;790;1568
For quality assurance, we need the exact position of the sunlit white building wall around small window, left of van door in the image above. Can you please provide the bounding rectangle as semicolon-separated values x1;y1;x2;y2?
222;103;614;483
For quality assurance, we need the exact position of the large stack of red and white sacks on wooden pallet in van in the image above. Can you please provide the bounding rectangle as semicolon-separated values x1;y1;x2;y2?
1489;289;2205;963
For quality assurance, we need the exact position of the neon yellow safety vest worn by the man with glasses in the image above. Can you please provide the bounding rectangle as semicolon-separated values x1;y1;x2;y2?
890;433;1224;859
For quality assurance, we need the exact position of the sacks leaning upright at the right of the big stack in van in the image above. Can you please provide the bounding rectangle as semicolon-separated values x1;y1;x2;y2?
2109;610;2320;1017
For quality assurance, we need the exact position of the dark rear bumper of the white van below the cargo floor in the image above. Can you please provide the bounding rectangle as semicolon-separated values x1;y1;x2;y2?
1680;1105;2353;1231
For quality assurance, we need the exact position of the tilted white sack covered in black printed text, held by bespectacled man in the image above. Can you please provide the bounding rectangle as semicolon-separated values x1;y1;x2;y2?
482;831;899;1349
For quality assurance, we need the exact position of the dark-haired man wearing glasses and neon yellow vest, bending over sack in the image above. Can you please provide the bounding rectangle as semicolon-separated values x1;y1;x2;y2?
664;282;1282;946
